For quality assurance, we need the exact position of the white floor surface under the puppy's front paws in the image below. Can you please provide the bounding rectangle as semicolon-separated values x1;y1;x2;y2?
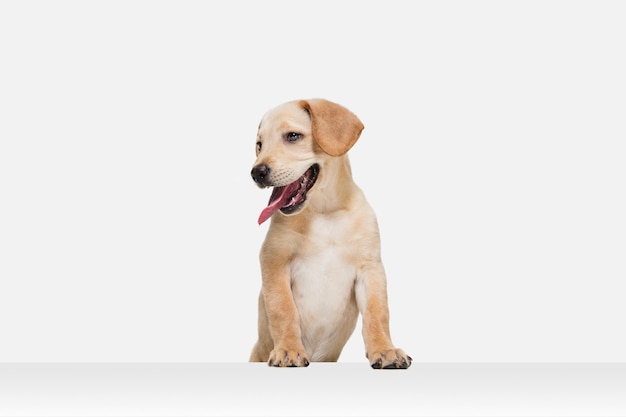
0;362;626;417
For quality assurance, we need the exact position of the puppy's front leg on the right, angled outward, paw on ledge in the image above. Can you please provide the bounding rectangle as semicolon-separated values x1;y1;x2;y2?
355;261;412;369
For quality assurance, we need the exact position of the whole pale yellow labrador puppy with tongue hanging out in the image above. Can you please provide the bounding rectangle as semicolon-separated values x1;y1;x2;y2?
250;99;412;369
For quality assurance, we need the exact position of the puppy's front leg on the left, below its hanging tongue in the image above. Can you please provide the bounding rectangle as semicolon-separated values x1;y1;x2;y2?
261;250;309;367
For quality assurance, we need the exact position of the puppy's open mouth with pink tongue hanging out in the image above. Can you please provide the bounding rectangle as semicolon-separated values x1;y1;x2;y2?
259;164;320;224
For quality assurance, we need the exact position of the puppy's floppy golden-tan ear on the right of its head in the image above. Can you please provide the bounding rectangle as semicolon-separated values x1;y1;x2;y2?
299;98;363;156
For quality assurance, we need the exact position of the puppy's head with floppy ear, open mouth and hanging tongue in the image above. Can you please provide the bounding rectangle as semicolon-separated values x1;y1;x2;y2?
251;99;363;224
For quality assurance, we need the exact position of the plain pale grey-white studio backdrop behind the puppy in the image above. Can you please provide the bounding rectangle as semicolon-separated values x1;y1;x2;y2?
0;1;626;362
